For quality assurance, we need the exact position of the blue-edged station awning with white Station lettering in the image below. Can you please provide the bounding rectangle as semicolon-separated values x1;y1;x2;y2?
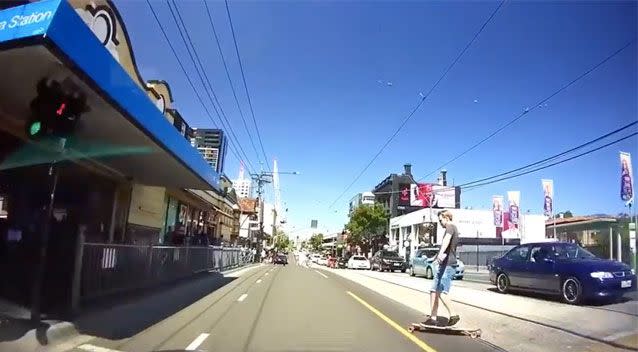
0;0;220;189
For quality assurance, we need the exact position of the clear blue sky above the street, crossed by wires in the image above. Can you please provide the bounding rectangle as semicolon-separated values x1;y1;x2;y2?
116;1;638;236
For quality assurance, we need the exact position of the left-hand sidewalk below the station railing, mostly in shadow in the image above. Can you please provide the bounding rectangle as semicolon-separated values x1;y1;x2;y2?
0;264;259;352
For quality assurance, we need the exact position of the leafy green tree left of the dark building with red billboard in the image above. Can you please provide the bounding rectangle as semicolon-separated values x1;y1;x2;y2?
346;204;388;253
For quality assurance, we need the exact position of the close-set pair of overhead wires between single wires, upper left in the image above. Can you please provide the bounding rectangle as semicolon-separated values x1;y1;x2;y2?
166;0;259;173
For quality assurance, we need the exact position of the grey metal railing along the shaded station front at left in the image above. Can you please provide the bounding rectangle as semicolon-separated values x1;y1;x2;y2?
76;243;249;299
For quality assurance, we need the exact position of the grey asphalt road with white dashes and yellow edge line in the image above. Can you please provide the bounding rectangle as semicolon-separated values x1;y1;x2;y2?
67;264;508;352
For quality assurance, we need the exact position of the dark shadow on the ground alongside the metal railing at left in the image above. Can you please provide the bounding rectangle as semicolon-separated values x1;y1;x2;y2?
73;272;235;340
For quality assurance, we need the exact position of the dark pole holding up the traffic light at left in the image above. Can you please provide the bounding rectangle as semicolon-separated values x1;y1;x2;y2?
31;161;58;322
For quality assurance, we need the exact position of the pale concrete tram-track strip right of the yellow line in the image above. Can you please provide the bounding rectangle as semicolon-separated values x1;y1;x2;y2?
321;267;638;352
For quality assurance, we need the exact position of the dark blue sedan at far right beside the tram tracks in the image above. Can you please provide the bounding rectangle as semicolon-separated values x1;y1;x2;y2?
489;242;636;304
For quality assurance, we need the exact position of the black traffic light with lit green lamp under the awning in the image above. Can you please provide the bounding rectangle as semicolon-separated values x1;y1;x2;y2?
26;78;89;140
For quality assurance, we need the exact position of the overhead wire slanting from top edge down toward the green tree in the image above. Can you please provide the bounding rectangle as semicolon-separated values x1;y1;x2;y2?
328;0;505;209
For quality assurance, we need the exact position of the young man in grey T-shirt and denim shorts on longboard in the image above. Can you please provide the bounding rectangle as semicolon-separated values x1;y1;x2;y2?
423;210;461;326
